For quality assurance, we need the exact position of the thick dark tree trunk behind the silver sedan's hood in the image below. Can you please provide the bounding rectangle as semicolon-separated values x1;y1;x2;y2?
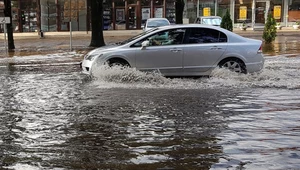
90;0;105;47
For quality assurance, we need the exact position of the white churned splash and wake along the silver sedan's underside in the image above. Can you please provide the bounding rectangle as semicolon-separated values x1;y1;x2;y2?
93;55;300;89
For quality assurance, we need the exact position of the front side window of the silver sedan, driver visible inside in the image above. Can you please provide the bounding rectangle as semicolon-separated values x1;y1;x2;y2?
132;29;185;47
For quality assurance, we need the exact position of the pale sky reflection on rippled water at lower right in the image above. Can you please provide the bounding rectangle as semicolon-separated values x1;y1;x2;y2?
214;89;300;169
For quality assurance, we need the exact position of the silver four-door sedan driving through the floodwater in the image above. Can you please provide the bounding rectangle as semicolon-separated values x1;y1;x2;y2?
81;24;264;76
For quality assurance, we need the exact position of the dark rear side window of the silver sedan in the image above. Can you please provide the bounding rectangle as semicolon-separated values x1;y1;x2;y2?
187;28;227;44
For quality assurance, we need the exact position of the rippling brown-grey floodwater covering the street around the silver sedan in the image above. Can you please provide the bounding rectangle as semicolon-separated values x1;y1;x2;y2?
0;53;300;170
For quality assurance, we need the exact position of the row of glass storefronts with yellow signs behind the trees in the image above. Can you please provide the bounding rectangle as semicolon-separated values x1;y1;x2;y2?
0;0;300;32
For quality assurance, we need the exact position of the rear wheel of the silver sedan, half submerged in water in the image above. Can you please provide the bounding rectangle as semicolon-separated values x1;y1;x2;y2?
219;58;247;74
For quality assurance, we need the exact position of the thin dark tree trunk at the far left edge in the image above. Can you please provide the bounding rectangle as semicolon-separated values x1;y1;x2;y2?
4;0;15;50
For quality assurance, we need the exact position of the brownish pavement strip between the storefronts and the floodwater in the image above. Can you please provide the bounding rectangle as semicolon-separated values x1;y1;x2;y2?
0;27;300;57
